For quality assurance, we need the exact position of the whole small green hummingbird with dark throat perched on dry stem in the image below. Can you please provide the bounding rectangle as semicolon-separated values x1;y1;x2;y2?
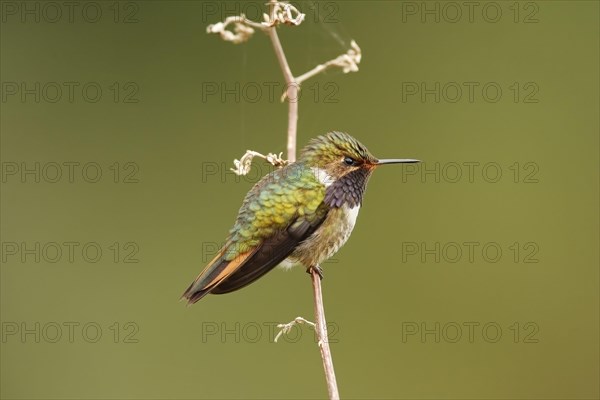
182;131;419;304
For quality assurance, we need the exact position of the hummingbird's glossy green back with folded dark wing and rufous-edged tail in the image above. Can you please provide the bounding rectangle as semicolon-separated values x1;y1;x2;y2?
182;163;329;304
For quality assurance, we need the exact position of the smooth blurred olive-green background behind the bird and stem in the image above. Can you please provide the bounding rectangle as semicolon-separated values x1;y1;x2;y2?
0;1;600;399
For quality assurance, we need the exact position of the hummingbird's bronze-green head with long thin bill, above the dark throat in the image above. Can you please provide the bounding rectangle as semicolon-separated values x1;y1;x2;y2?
300;131;419;180
